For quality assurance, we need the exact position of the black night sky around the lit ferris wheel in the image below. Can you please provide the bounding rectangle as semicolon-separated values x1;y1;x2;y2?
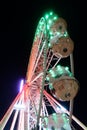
0;0;87;129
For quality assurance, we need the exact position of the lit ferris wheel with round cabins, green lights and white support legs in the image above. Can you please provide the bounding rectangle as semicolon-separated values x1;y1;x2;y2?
0;12;87;130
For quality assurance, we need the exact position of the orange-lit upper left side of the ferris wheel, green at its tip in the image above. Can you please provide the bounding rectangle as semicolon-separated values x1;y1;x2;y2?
26;18;46;83
